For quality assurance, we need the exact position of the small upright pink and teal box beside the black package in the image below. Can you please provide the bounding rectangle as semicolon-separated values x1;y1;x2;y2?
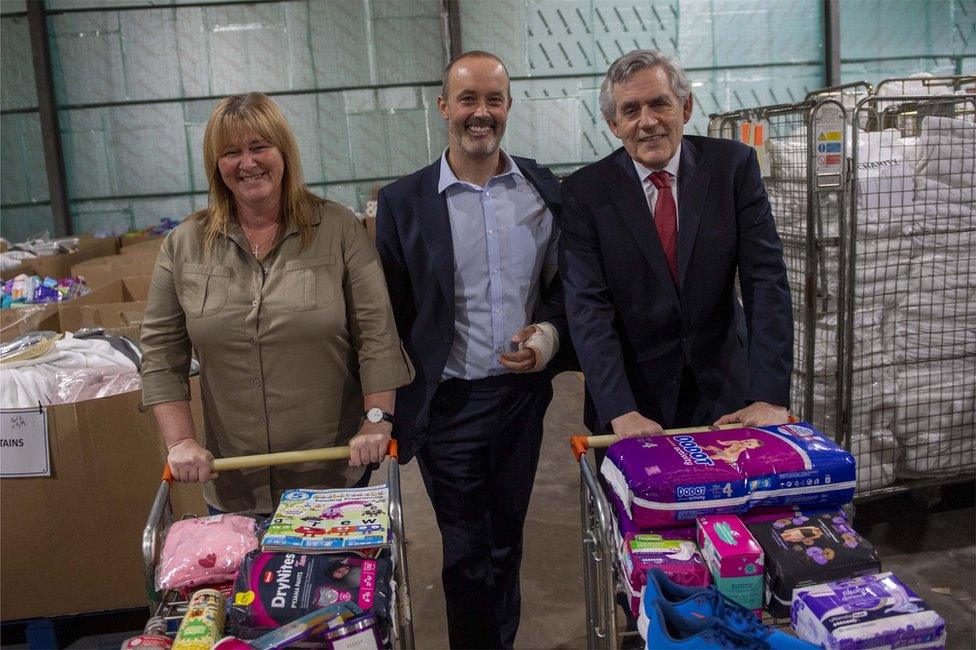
698;515;764;614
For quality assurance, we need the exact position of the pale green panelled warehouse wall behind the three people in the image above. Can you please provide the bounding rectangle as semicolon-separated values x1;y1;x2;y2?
0;0;976;240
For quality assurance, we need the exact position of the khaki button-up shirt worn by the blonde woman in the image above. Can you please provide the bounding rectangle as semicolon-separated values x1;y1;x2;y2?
142;201;413;513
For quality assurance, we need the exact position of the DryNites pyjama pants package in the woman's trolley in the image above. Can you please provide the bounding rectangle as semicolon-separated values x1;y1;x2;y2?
229;551;392;636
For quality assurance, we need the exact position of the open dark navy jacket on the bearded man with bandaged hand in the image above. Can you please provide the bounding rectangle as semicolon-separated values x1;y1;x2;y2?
376;156;575;462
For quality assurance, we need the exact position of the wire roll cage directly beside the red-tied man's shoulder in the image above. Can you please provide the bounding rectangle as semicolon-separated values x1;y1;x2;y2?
709;97;848;442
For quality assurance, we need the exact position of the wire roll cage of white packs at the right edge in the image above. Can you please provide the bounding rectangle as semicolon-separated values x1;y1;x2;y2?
843;91;976;498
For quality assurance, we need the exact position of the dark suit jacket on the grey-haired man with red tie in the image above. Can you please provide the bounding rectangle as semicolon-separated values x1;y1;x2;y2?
559;136;793;431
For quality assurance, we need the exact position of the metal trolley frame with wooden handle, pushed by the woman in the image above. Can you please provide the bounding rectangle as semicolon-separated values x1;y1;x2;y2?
142;440;414;650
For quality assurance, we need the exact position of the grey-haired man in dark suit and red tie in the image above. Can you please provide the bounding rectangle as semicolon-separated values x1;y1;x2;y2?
559;50;793;436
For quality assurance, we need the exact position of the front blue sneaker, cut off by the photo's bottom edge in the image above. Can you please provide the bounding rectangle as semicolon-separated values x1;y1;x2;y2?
637;598;776;650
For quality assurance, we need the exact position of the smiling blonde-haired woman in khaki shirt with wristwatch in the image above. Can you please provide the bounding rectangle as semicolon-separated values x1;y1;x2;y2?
142;93;413;513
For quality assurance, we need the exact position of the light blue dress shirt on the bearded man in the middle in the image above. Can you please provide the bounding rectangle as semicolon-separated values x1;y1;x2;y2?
437;151;559;379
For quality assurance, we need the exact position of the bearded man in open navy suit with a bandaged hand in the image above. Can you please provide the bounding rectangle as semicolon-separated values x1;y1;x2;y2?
376;52;571;648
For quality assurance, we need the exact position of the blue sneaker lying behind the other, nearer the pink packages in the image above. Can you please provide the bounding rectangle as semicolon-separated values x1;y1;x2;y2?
641;568;817;650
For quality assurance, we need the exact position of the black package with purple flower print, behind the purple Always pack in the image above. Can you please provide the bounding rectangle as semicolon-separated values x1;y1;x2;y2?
747;511;881;618
